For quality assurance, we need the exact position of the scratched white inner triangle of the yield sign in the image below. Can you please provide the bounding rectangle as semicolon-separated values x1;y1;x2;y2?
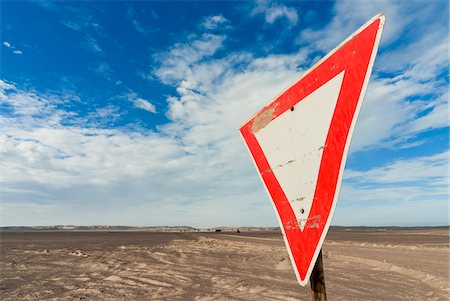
255;71;344;231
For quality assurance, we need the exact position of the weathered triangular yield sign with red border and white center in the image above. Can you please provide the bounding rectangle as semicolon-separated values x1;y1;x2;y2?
240;14;384;286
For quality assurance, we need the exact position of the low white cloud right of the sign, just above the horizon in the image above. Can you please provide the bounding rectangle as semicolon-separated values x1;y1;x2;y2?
334;151;450;226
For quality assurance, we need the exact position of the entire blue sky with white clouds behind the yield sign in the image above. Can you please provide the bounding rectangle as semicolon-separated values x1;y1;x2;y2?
0;1;449;227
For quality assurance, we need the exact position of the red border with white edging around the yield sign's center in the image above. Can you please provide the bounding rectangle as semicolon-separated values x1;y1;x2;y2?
240;14;385;286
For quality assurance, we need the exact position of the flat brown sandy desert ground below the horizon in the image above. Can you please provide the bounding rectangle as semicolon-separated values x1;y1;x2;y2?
0;228;450;301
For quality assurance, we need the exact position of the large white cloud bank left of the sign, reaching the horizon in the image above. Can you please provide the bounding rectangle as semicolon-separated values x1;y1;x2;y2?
0;36;310;226
